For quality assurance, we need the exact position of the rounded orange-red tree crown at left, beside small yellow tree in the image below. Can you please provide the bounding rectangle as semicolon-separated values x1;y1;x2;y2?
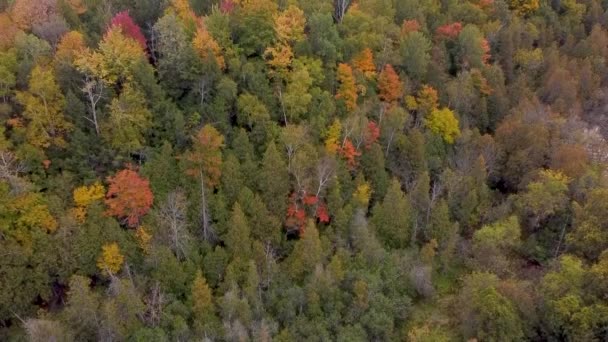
105;169;154;227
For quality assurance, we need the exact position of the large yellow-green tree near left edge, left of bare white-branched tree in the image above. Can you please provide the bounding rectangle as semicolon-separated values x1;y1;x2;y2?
17;65;73;148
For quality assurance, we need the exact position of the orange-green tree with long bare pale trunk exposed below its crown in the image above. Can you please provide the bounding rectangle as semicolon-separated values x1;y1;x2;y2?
184;125;224;239
